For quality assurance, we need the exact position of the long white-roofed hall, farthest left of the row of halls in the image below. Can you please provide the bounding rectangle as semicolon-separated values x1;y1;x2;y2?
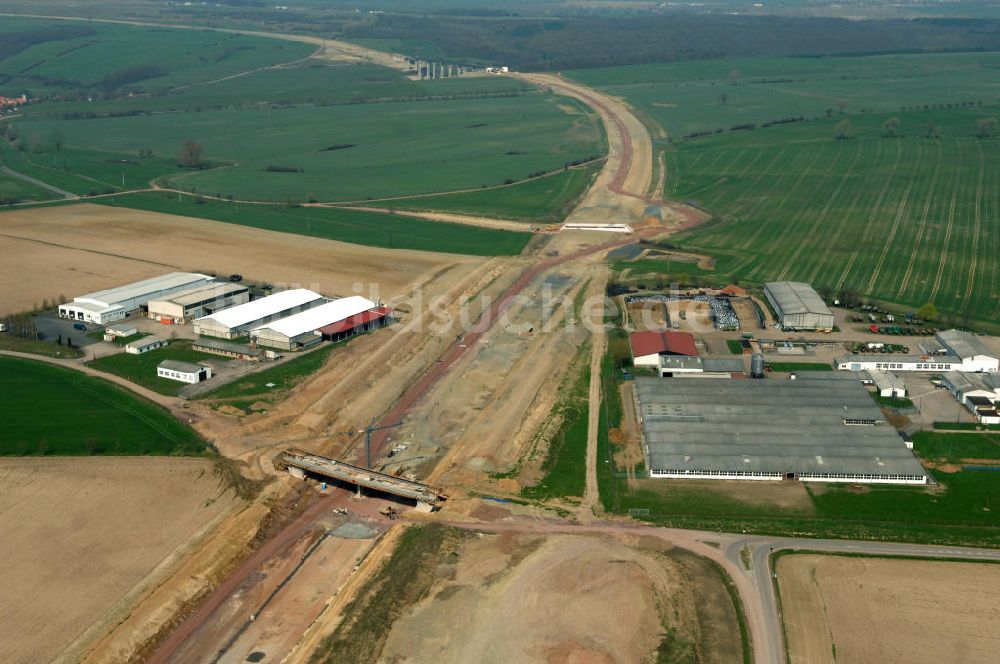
59;272;212;325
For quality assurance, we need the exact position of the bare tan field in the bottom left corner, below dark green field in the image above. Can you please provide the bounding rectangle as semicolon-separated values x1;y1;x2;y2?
0;457;239;662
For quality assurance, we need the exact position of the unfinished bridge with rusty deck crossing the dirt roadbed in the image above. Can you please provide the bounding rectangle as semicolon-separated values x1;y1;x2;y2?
274;449;447;512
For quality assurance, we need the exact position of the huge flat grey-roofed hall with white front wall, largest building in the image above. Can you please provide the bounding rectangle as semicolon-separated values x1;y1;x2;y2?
635;377;927;484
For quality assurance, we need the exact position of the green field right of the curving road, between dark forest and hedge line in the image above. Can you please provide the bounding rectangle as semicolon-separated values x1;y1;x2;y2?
568;53;1000;139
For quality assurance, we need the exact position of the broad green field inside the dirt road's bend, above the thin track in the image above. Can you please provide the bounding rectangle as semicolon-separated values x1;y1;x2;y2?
16;94;601;201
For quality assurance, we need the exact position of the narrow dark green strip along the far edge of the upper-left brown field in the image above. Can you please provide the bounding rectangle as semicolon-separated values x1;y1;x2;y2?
99;193;531;256
